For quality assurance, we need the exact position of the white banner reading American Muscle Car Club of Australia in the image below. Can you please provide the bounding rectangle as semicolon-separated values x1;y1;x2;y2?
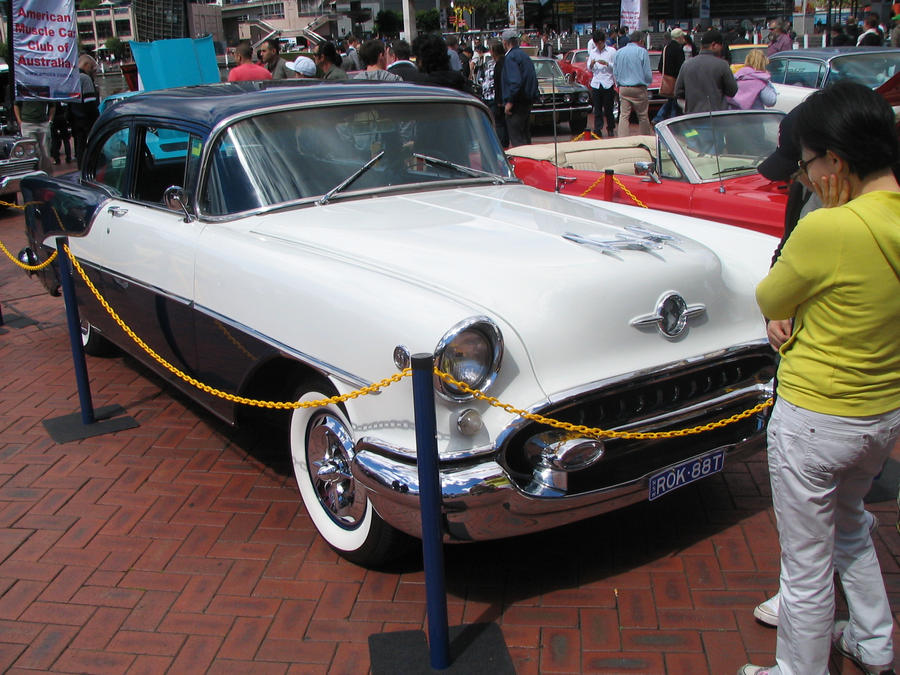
11;0;80;100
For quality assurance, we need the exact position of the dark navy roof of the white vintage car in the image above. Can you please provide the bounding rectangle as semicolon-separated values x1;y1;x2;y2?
98;80;477;128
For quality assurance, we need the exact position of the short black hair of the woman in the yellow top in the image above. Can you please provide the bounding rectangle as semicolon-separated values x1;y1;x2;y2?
794;80;900;178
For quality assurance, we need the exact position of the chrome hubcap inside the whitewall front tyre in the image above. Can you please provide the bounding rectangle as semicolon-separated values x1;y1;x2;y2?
306;413;366;529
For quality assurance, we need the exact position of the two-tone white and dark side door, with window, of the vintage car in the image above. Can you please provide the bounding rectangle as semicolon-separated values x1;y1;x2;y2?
71;123;203;380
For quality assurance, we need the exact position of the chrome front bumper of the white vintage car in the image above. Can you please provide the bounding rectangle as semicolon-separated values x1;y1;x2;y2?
352;428;765;542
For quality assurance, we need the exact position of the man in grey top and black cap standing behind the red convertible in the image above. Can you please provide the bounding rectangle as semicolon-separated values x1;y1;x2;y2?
675;30;737;113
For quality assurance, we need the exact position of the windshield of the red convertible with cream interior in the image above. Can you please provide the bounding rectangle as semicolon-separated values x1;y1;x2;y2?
666;112;783;180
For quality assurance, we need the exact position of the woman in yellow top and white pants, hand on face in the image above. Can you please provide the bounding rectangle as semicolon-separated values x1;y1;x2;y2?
738;82;900;675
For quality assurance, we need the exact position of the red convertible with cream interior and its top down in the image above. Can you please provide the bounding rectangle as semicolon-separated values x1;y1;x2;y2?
507;110;787;237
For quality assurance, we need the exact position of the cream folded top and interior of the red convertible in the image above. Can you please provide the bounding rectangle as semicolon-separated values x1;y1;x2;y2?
506;136;656;175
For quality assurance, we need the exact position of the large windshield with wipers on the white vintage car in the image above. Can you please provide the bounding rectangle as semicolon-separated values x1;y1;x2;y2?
200;101;512;216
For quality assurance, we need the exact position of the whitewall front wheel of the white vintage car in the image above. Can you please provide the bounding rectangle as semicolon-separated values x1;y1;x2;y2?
290;391;410;567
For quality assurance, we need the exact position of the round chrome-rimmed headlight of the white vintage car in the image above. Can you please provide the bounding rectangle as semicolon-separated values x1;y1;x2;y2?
434;317;503;401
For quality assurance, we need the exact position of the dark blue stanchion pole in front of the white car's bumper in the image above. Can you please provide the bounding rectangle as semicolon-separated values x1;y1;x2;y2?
412;354;458;670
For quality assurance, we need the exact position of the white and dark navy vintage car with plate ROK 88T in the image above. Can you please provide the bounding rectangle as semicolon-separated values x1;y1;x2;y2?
23;82;774;564
